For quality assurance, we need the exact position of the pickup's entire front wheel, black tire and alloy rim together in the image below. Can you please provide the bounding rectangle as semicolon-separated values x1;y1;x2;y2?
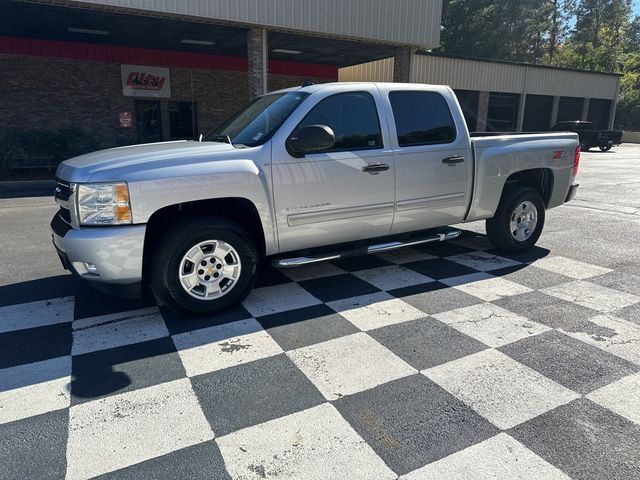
150;216;258;315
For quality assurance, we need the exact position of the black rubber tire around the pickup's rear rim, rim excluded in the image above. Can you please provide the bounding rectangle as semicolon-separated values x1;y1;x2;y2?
486;186;545;253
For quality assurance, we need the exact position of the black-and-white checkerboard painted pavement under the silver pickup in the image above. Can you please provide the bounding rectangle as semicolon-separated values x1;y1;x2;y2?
0;233;640;480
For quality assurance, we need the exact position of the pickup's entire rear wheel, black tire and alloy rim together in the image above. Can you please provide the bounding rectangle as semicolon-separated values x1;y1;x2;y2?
486;186;545;253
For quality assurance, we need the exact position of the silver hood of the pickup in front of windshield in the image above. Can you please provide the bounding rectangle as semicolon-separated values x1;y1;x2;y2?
56;140;236;182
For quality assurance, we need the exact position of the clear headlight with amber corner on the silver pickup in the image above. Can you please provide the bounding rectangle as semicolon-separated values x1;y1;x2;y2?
77;182;131;225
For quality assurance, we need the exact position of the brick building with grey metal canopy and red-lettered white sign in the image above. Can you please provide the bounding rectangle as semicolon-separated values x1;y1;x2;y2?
0;0;441;180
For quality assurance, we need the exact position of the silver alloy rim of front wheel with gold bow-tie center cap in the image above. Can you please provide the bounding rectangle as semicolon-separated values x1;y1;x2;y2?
178;240;241;300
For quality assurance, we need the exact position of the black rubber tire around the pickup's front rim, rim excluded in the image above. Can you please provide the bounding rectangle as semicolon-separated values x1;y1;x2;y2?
149;216;259;316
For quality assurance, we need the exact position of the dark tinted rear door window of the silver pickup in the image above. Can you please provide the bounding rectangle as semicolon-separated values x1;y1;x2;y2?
389;91;456;147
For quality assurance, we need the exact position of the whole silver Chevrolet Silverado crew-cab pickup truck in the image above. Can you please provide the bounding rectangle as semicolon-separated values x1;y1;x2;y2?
52;83;580;314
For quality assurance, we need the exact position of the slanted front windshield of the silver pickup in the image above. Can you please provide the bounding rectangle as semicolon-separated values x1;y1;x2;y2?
204;92;309;147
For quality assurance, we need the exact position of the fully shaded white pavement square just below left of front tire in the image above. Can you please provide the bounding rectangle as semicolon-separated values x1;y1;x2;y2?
71;307;169;355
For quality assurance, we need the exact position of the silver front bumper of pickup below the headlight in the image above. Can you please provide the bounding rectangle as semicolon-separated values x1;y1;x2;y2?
51;213;146;285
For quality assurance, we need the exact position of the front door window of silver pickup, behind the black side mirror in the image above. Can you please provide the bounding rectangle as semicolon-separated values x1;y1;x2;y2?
298;92;382;151
